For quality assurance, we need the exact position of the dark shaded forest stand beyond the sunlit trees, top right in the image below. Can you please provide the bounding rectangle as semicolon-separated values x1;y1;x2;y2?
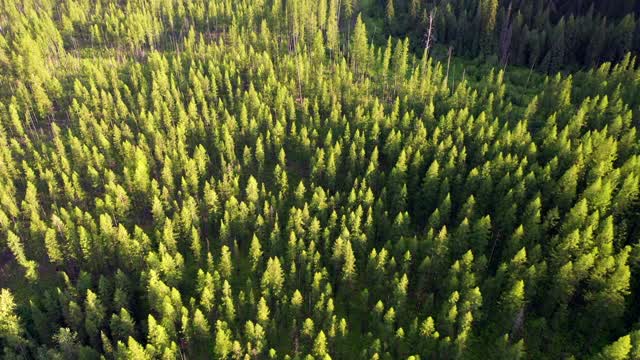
360;0;640;73
